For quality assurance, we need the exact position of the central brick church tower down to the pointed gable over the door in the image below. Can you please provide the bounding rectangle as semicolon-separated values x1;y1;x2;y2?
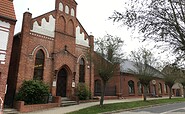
54;0;77;56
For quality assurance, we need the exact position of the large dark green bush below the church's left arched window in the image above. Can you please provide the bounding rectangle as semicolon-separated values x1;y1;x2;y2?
16;80;49;104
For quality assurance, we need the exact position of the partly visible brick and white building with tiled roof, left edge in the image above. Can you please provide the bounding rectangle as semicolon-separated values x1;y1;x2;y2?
0;0;16;108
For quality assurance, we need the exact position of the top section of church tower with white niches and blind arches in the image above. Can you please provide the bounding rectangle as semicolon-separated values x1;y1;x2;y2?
55;0;77;37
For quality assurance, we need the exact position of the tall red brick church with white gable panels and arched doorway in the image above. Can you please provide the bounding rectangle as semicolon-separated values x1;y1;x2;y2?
5;0;94;106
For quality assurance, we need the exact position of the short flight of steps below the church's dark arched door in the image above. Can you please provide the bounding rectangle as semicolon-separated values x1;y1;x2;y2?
60;97;78;107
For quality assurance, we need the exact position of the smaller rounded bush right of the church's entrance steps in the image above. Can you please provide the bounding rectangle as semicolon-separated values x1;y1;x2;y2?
77;83;91;100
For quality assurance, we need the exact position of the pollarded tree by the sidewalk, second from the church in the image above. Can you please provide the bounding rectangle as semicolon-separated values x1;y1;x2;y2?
130;48;162;101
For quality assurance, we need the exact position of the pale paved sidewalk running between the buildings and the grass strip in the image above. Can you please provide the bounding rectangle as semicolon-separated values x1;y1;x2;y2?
21;97;169;114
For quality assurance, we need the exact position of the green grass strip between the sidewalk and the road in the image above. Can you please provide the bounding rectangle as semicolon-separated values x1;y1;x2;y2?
68;98;185;114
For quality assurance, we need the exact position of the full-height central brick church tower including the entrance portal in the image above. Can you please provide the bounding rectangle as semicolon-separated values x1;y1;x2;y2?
53;0;78;97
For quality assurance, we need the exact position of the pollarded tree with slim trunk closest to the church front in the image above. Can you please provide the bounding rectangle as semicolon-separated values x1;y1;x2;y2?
93;34;124;106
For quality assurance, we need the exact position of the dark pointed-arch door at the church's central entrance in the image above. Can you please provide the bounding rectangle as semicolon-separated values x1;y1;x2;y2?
56;68;68;97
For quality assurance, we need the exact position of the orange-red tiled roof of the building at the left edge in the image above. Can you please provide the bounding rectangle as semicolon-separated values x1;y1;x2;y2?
0;0;16;20
